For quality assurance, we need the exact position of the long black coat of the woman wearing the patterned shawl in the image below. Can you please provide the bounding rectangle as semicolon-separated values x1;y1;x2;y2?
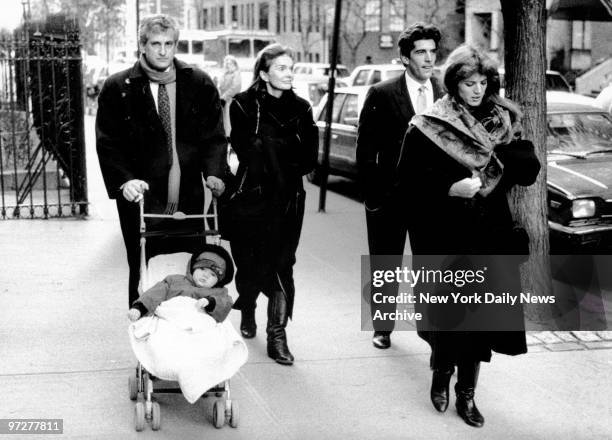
399;126;540;362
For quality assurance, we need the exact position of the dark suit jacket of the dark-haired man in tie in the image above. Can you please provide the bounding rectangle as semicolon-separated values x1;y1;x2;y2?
357;75;442;214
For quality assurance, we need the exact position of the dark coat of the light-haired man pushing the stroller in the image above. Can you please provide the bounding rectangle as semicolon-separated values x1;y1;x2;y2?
96;60;227;213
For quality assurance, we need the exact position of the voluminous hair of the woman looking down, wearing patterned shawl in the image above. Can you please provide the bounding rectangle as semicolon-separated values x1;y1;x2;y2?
444;44;499;98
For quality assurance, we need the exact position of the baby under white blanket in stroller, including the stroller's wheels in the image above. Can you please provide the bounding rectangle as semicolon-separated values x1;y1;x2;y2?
128;244;248;431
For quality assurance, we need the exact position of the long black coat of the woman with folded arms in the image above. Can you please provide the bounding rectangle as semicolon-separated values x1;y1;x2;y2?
230;87;319;316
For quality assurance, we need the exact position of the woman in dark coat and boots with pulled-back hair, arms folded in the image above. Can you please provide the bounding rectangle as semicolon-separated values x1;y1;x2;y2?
230;44;318;365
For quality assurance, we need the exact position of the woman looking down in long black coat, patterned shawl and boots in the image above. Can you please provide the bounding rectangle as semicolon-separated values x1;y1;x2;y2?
399;45;540;427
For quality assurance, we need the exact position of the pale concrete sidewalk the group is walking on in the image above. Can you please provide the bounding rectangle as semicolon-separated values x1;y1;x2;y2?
0;118;612;440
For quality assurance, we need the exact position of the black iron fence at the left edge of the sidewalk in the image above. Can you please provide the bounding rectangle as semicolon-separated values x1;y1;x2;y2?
0;28;88;219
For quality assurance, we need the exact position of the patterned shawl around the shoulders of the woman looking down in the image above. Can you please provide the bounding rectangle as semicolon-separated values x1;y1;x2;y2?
410;94;521;197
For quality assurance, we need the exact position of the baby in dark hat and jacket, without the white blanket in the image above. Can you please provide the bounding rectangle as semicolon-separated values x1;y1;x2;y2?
128;244;234;322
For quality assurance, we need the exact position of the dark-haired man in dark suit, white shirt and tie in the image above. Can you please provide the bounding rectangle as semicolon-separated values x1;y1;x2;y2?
357;23;442;349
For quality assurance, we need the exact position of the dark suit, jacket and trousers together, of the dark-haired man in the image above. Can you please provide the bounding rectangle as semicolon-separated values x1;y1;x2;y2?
357;74;441;332
